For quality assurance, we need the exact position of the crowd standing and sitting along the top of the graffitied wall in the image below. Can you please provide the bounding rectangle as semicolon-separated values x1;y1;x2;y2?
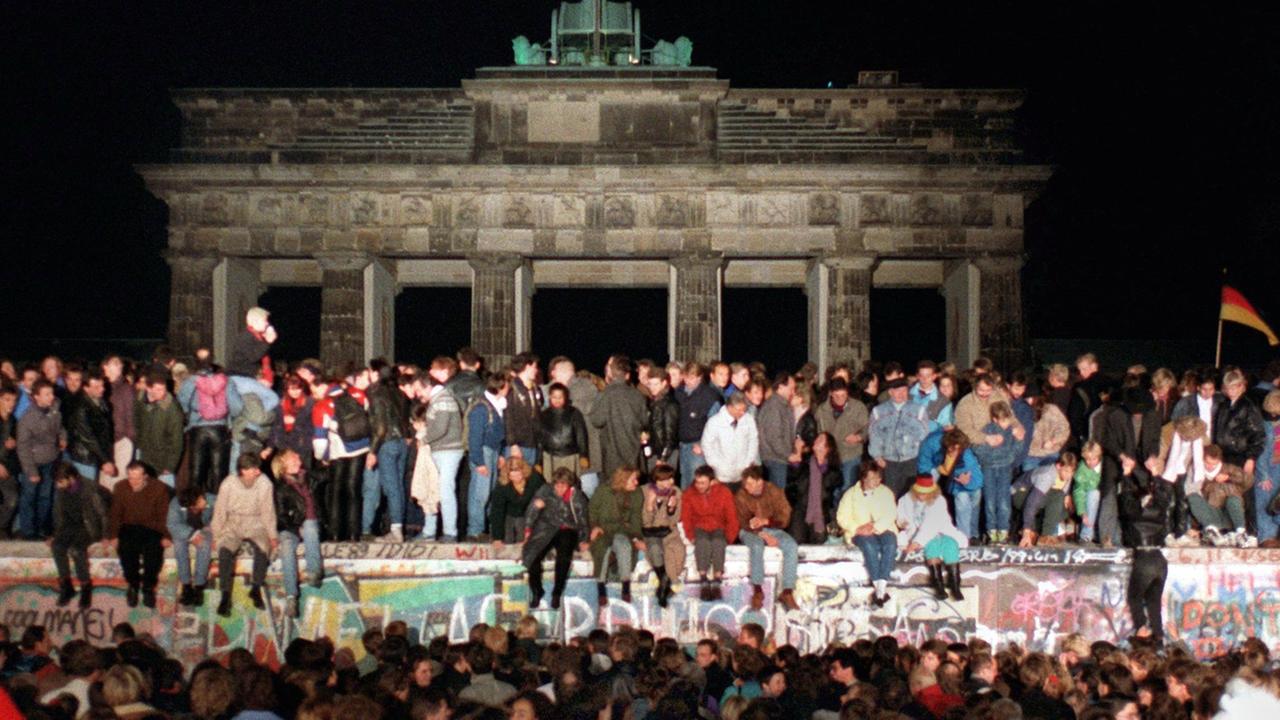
0;307;1280;622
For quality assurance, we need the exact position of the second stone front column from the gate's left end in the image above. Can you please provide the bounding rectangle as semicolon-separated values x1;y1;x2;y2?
316;252;374;369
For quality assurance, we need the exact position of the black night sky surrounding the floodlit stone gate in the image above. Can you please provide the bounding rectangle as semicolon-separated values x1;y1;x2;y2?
0;0;1280;364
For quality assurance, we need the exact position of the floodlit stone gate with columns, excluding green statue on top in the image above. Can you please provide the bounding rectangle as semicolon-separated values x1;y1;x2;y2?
140;68;1050;366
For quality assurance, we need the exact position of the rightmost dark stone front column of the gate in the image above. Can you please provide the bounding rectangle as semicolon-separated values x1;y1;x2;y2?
974;255;1027;374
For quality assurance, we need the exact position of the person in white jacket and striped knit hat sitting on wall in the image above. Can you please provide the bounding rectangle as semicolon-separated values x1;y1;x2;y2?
897;475;969;600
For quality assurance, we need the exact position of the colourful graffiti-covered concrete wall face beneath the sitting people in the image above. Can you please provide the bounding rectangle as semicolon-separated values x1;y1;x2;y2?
0;543;1280;665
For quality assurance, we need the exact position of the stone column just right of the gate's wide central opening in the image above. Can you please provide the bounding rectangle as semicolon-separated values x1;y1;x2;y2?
668;254;724;363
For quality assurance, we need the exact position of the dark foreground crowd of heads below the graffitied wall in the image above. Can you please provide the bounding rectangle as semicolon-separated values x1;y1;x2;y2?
0;616;1280;720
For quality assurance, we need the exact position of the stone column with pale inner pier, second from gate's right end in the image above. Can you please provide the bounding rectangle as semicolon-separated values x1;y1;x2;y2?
808;255;876;370
